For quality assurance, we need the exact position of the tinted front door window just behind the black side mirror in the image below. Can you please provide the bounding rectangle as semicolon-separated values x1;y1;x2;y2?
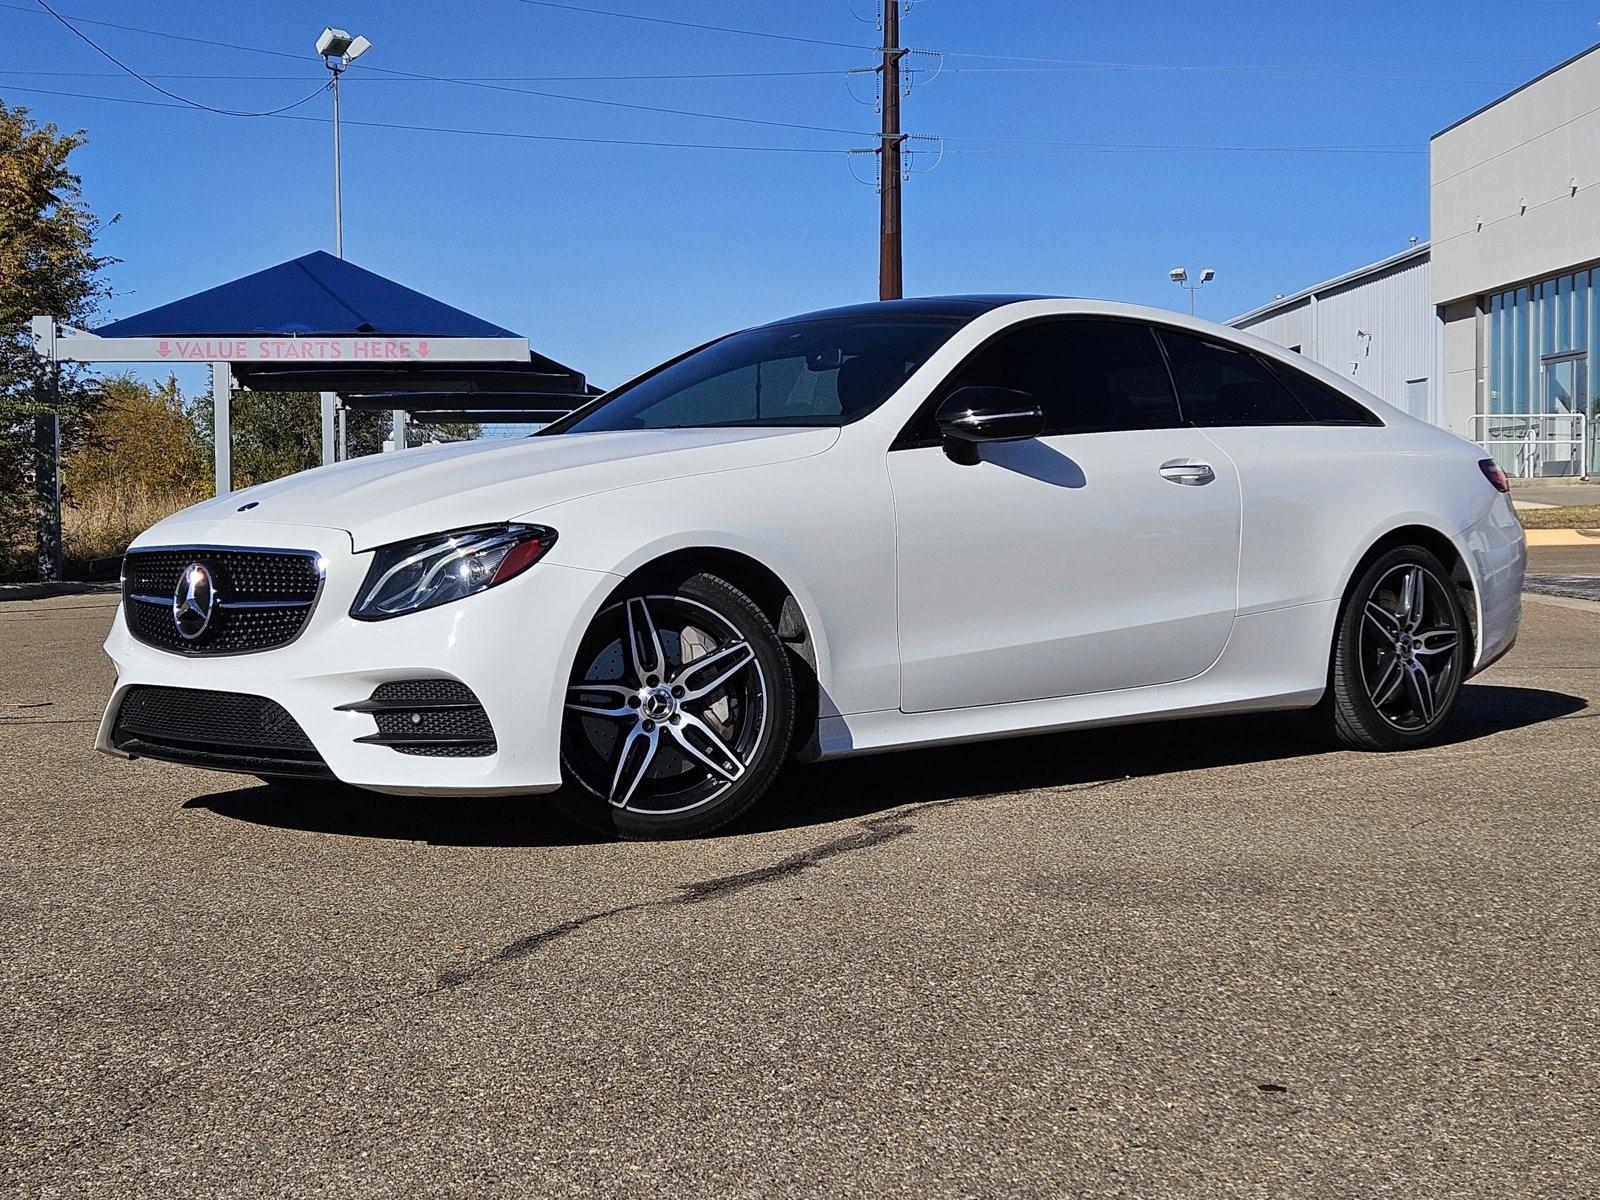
925;320;1182;435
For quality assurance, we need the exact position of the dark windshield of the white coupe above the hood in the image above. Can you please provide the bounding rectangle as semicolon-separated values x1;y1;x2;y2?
544;317;965;434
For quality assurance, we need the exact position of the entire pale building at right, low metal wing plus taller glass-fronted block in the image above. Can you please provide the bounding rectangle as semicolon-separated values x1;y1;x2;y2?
1232;46;1600;477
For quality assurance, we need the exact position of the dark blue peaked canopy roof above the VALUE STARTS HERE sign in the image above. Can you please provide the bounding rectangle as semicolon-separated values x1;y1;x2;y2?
94;250;518;338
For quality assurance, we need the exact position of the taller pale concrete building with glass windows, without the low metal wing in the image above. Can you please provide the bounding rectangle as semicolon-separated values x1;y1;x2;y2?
1429;46;1600;475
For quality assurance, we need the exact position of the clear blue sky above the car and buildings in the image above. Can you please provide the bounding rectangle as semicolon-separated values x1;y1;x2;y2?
0;0;1600;386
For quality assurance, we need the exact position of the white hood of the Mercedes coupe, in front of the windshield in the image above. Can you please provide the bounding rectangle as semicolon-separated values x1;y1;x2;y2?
136;429;838;550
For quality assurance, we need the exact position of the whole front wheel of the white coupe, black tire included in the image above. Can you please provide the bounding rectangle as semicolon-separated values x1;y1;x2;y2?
552;573;795;838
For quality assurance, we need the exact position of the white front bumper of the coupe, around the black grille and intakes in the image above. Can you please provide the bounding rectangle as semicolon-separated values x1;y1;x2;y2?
94;526;618;795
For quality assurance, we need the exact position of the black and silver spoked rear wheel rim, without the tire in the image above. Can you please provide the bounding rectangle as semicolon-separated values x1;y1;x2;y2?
1360;563;1461;731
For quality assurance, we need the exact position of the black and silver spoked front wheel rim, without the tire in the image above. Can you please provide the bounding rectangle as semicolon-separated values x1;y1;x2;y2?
562;595;768;814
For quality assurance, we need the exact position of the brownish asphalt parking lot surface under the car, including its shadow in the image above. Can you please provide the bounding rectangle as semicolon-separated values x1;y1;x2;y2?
0;579;1600;1198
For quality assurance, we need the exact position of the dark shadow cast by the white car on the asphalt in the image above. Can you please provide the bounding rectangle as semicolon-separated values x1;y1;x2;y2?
184;683;1589;846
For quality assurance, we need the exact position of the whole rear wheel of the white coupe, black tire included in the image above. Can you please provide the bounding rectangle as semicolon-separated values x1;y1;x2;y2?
1318;546;1472;750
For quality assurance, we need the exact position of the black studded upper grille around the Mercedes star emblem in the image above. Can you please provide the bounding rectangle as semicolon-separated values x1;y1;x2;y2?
122;546;322;654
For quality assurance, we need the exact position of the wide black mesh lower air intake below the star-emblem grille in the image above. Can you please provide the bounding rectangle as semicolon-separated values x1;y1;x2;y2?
112;685;330;776
